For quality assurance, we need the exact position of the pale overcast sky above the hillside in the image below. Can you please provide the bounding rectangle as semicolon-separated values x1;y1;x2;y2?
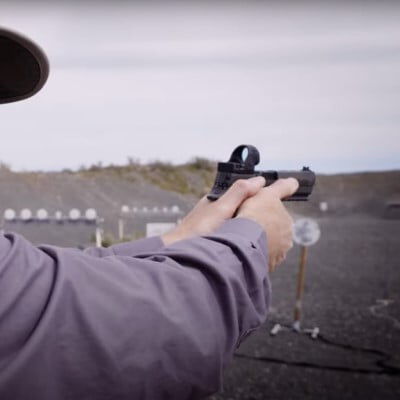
0;0;400;173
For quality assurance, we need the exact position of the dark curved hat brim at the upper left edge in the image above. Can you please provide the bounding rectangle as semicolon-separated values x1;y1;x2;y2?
0;27;49;104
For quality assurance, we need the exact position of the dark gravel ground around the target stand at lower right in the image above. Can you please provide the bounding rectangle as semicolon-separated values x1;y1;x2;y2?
211;216;400;400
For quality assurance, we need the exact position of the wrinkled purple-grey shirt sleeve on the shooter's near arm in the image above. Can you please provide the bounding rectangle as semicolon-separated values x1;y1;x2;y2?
0;218;270;400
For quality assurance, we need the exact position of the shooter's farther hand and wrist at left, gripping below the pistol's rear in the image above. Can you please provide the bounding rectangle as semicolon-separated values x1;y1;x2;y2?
162;176;265;245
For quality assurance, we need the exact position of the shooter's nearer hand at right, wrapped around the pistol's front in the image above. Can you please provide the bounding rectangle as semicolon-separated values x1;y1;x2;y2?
237;178;299;271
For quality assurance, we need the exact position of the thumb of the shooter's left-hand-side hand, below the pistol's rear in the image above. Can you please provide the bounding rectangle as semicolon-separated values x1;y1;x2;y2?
217;176;266;213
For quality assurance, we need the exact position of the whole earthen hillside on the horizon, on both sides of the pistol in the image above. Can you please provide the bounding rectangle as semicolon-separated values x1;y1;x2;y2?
0;159;400;246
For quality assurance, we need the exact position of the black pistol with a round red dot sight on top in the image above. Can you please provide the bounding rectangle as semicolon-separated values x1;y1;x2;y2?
207;144;315;201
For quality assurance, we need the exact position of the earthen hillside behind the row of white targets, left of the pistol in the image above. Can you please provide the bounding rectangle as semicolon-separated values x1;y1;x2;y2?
0;159;215;246
